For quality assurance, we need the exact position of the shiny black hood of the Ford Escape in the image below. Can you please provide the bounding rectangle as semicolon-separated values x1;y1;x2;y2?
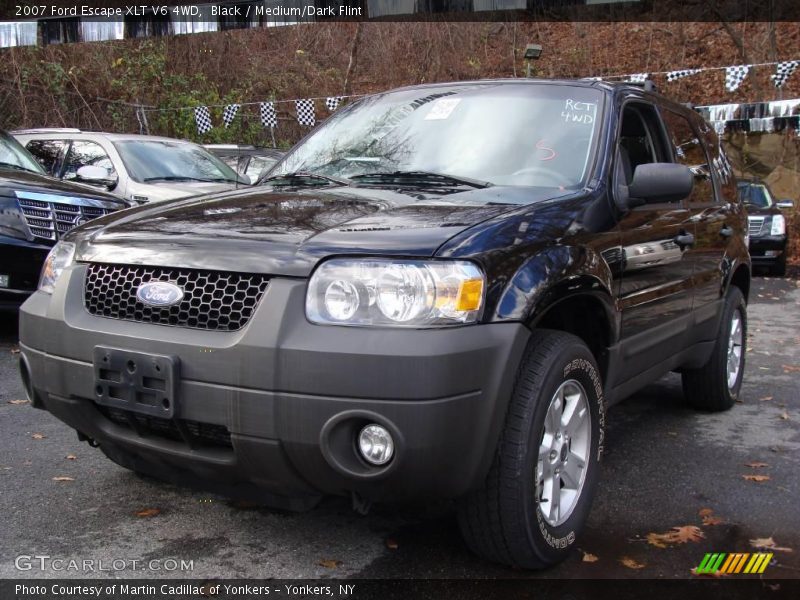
73;186;565;277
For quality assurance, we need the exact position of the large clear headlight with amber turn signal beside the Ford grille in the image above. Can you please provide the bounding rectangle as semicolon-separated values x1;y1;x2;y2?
306;258;484;327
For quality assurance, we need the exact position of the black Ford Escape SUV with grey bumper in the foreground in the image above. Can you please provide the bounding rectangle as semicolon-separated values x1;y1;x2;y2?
20;80;750;568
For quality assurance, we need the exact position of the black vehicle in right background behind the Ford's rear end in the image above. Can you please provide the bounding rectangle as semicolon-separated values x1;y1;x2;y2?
738;179;793;277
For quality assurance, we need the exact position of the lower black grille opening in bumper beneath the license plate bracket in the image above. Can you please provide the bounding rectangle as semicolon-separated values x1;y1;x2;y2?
97;406;233;448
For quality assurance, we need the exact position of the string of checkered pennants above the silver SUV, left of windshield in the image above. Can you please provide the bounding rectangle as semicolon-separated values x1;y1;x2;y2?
147;94;363;135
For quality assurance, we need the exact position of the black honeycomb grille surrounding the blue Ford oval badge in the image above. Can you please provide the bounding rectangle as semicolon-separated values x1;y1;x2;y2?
84;263;269;331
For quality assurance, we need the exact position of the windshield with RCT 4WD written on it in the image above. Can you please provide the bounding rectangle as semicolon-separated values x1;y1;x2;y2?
270;83;603;189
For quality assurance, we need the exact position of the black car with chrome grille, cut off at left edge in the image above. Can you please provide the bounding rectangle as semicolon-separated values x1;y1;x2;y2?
0;131;127;310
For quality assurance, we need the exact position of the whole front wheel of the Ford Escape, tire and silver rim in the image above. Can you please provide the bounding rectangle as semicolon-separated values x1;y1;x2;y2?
459;330;604;569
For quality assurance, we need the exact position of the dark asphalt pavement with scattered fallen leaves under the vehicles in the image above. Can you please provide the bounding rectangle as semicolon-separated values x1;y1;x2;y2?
0;277;800;579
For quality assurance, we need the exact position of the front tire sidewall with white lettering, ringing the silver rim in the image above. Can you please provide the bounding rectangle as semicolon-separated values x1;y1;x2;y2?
522;340;605;563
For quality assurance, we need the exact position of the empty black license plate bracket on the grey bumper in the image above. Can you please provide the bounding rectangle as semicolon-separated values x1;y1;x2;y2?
93;346;180;419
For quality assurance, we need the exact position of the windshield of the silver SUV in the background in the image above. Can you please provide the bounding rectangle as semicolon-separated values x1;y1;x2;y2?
114;140;241;183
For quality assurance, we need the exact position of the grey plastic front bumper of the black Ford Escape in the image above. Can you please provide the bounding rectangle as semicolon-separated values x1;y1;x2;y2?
20;265;529;501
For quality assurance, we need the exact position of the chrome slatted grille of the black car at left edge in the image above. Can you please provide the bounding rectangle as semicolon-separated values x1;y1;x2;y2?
16;192;119;241
